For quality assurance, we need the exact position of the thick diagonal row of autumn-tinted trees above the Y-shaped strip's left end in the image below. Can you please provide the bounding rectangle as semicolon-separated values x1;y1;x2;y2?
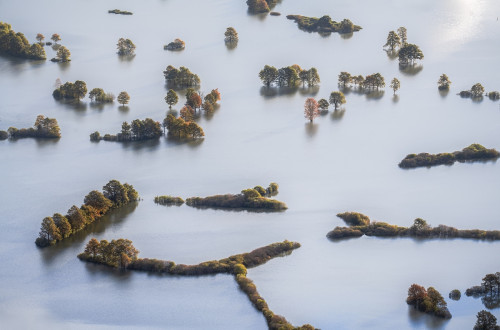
35;180;139;247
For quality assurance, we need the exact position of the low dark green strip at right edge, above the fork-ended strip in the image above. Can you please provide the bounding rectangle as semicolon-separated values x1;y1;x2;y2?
399;143;500;169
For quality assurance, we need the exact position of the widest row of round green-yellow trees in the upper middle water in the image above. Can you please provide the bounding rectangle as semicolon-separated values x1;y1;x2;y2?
259;64;321;87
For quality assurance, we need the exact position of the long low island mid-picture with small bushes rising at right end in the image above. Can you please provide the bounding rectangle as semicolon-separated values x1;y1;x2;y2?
186;184;288;211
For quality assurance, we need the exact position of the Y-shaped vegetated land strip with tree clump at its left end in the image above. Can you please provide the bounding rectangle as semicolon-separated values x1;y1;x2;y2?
78;238;314;330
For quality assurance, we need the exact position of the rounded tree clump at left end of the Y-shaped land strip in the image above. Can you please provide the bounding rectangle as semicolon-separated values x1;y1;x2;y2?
78;238;139;269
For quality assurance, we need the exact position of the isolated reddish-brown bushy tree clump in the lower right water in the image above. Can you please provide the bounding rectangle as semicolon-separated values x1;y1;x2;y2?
406;284;451;319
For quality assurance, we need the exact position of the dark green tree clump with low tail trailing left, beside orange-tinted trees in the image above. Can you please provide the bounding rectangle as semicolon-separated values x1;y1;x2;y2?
90;118;163;142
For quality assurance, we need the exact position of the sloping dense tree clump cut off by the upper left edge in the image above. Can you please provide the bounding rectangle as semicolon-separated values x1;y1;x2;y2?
0;22;47;60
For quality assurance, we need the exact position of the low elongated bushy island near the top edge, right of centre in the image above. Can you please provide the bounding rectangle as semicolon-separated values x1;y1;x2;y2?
286;15;362;33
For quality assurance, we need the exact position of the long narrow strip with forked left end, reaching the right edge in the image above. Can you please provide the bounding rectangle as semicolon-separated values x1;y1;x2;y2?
326;212;500;241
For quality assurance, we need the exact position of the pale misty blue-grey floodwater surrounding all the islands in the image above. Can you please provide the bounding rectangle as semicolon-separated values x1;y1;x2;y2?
0;0;500;329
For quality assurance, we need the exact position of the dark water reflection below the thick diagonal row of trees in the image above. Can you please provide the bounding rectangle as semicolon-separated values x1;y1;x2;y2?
39;202;139;265
